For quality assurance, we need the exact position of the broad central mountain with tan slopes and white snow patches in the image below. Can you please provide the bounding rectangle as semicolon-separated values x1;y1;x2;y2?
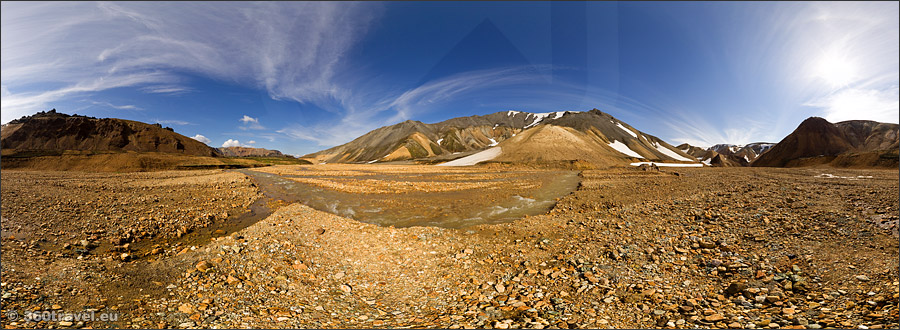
304;109;695;165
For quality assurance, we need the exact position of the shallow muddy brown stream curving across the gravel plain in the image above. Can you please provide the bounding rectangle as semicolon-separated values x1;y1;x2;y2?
239;169;579;228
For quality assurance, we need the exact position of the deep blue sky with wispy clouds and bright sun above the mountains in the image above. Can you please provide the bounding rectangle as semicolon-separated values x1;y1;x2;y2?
0;2;900;155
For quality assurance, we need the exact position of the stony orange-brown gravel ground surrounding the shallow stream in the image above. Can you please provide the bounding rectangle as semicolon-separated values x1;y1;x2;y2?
2;166;900;329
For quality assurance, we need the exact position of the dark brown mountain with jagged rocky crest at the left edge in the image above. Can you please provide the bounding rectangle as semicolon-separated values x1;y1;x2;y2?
0;109;220;156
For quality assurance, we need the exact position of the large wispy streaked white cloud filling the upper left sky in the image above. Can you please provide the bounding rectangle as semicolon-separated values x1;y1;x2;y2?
0;2;380;122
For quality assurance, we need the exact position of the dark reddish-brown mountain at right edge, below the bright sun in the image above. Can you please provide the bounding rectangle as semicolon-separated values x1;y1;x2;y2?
751;117;900;167
